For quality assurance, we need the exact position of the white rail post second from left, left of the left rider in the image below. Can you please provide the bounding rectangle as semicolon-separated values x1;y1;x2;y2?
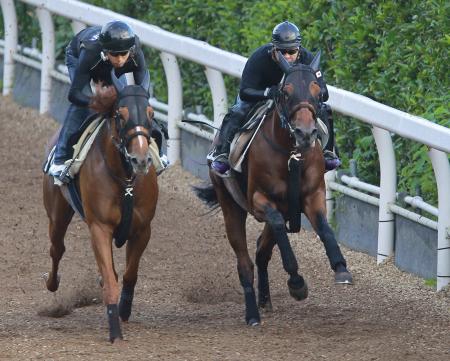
36;8;55;114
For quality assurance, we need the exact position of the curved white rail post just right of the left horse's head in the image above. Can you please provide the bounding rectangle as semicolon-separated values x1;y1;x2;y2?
160;52;183;164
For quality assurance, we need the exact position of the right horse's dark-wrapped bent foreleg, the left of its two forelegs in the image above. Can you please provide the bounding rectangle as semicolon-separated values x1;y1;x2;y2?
253;192;308;301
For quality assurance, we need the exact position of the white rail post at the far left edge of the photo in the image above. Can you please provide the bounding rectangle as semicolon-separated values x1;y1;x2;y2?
1;0;17;95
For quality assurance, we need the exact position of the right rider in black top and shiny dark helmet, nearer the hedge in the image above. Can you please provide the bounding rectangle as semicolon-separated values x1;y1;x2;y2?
207;21;341;174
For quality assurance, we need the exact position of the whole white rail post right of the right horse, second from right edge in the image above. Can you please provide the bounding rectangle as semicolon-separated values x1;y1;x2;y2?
372;127;397;264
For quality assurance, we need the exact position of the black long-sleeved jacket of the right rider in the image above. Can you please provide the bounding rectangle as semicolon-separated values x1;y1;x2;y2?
239;43;328;102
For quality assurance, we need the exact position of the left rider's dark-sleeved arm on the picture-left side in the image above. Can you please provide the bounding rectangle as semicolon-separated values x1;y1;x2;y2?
68;49;92;107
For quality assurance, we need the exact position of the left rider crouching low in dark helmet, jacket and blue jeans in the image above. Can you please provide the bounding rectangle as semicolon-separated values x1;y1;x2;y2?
49;20;166;183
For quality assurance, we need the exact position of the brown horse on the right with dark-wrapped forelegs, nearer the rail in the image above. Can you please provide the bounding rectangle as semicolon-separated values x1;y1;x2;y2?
195;53;352;326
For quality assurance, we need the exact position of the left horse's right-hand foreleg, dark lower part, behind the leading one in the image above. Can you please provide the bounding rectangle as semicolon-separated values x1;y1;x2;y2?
119;225;151;321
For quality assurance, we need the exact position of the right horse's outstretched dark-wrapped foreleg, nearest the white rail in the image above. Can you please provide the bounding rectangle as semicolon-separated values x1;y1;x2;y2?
304;192;353;284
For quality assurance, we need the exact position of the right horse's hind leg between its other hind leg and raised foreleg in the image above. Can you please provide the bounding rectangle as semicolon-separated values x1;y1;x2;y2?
255;223;275;312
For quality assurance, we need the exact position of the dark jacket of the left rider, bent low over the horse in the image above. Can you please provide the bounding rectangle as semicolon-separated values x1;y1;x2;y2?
66;26;147;107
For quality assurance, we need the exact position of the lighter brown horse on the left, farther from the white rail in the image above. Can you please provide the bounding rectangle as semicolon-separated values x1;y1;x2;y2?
43;72;158;342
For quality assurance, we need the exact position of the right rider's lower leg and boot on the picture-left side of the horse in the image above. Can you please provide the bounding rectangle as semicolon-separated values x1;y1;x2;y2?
208;112;241;174
